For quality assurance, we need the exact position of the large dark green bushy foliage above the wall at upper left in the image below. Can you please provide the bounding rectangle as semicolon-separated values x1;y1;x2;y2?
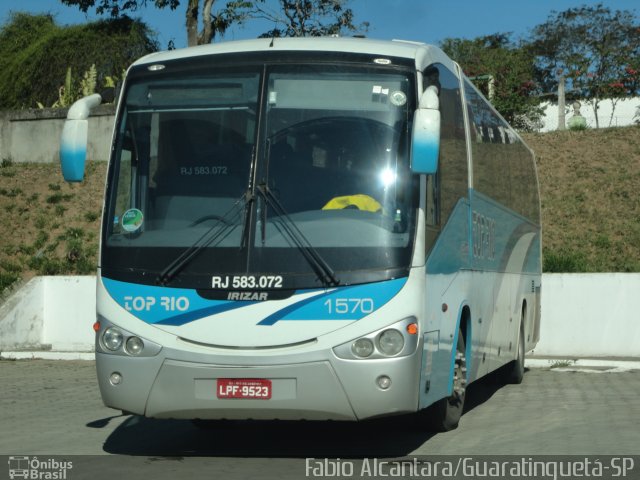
0;13;158;108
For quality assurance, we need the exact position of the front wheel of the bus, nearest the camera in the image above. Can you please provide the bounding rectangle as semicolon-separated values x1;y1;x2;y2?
418;330;467;432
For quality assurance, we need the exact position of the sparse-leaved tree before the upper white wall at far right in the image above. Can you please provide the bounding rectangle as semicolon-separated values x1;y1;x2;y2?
530;4;640;127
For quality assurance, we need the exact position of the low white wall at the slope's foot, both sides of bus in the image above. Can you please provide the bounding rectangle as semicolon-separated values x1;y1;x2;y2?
0;273;640;358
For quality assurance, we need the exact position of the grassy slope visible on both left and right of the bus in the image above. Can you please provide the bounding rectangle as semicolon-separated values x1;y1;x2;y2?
0;126;640;294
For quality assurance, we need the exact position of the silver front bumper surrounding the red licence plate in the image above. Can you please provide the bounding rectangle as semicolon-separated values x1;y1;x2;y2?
96;353;420;420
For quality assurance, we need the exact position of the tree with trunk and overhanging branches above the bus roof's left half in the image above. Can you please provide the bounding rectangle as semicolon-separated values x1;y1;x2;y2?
61;0;368;47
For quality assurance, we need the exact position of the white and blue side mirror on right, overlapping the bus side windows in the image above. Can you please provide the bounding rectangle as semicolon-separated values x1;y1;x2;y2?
411;85;440;175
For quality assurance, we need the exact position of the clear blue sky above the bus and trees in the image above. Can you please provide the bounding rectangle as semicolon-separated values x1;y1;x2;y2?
0;0;640;49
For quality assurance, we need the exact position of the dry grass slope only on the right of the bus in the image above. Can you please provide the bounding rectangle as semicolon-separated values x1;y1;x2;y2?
523;126;640;272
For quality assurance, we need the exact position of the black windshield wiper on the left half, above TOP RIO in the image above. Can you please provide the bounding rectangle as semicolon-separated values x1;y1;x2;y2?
156;192;251;285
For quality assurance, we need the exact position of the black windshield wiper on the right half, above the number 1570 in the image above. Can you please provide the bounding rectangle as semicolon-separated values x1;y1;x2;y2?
256;183;340;287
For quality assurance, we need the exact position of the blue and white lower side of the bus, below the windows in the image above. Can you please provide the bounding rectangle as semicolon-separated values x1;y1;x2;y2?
420;191;541;408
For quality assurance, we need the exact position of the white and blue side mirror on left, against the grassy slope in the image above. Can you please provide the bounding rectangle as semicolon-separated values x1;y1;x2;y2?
60;93;102;182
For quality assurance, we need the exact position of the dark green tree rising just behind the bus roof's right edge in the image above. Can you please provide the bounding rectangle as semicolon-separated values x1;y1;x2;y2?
440;33;542;130
